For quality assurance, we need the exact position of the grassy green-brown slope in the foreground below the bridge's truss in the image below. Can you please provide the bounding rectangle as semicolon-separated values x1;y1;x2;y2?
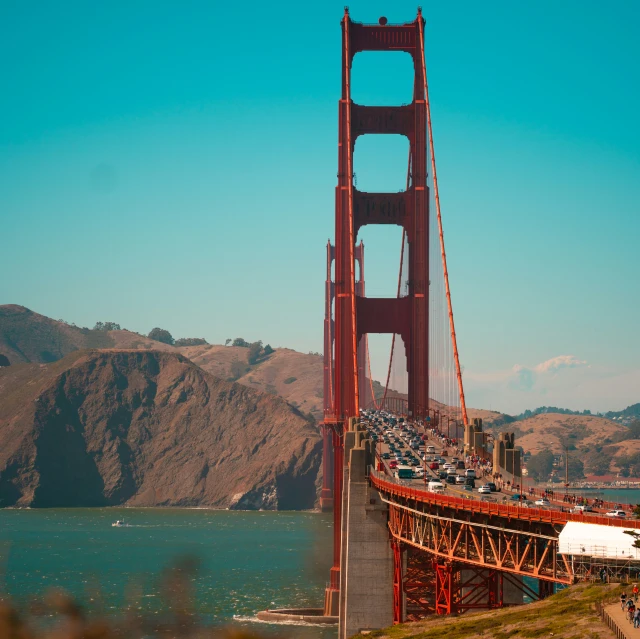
369;583;622;639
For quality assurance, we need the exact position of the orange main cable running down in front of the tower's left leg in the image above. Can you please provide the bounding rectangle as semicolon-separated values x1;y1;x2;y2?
344;13;360;417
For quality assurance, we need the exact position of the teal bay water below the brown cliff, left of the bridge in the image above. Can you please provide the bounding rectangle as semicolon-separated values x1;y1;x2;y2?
0;508;337;639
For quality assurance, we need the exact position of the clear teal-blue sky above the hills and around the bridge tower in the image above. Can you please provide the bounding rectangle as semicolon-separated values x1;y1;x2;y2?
0;0;640;413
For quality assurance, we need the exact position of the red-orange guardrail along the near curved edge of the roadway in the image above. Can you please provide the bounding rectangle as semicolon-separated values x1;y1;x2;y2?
369;468;640;529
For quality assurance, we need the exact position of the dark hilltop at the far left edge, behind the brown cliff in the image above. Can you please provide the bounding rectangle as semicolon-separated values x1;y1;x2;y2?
0;304;114;364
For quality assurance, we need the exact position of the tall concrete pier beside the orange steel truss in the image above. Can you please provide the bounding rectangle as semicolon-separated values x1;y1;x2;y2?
338;430;393;639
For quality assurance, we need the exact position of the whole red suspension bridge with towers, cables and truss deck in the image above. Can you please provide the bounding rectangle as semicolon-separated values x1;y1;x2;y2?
266;10;638;639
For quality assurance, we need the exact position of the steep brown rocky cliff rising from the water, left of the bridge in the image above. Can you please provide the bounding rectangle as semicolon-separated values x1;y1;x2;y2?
0;350;322;509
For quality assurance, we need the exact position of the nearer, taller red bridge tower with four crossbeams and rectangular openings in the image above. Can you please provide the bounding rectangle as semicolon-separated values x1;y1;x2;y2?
324;9;429;632
